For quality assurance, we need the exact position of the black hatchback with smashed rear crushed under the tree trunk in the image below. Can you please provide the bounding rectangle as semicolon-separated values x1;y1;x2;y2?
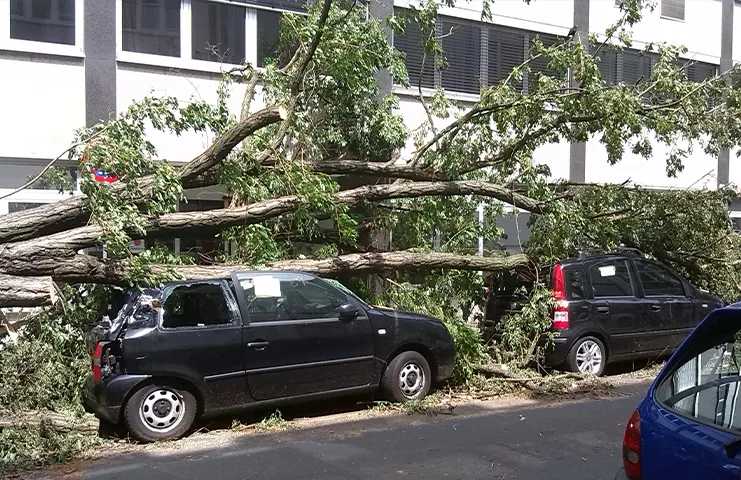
85;271;455;441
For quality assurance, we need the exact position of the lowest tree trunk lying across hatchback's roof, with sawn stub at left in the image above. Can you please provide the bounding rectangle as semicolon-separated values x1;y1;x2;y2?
0;251;529;307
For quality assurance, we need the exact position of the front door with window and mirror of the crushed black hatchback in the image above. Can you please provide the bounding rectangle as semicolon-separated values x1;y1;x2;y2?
234;272;374;400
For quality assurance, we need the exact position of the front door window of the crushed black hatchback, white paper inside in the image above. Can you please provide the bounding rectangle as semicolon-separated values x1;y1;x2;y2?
240;274;347;322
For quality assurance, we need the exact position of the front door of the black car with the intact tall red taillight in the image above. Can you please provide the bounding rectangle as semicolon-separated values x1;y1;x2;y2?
634;260;694;354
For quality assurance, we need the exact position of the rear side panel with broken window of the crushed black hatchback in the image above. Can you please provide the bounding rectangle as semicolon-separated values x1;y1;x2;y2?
142;280;247;409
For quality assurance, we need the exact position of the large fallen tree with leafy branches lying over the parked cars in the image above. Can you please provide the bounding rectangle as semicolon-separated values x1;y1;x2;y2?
0;0;741;306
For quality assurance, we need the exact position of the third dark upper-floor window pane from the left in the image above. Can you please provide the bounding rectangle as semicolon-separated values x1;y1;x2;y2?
191;0;246;64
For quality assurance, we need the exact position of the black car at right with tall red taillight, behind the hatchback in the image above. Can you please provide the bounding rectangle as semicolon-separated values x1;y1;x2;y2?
486;251;724;375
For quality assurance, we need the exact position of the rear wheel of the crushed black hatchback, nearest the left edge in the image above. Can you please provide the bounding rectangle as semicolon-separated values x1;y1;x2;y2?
124;384;198;442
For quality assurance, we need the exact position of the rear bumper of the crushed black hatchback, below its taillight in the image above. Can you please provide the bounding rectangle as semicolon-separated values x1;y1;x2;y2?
83;375;149;424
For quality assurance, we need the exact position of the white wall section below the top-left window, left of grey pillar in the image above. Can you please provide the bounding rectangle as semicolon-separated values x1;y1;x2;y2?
0;52;85;160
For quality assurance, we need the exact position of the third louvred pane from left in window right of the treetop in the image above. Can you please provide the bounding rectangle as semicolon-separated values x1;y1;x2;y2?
488;27;527;89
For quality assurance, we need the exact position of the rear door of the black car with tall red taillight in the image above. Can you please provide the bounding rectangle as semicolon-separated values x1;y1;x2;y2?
589;259;642;356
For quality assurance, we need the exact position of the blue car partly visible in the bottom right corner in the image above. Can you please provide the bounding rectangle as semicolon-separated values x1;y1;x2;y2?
615;304;741;480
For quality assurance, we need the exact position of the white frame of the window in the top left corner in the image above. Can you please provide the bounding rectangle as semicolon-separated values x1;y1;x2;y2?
0;0;84;58
